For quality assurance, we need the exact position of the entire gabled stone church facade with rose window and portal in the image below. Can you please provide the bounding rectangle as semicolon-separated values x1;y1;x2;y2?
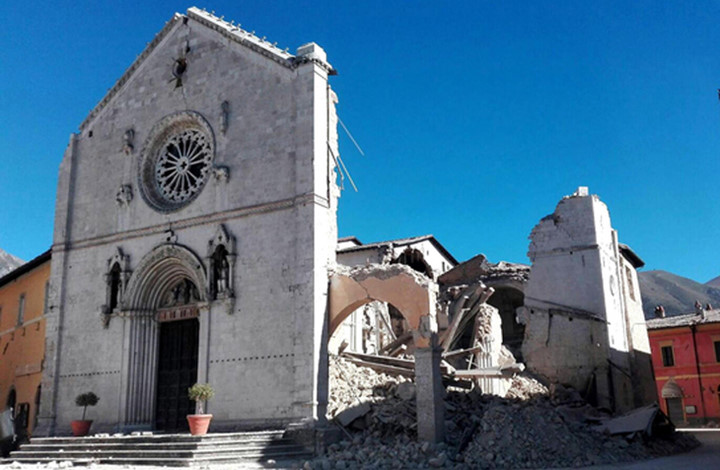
38;8;339;434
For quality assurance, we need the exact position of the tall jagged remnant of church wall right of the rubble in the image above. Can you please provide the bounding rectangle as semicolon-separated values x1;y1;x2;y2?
520;187;652;411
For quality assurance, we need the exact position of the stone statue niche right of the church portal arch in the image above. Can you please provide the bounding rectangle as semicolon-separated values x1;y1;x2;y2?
205;224;237;304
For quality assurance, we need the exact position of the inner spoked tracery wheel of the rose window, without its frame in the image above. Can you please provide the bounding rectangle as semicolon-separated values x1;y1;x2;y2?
155;129;212;202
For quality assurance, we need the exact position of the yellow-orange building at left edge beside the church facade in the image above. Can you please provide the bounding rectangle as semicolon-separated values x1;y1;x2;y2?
0;250;50;437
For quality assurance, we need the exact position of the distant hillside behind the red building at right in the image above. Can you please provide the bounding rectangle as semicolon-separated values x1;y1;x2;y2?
638;271;720;318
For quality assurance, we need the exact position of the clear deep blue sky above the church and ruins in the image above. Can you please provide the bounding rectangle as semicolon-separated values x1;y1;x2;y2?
0;0;720;282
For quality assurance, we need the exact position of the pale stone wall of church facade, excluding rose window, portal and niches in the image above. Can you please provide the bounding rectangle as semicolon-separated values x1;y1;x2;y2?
40;10;338;433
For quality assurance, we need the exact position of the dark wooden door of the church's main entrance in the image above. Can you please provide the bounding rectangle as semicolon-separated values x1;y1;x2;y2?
155;318;199;432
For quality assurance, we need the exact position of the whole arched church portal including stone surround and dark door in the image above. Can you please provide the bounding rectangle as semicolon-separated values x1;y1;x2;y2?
122;244;208;431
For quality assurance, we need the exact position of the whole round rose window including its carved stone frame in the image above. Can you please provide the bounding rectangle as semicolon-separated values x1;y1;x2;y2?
139;112;215;212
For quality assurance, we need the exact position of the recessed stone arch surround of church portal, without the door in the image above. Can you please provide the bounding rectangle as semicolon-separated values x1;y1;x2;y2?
121;244;209;429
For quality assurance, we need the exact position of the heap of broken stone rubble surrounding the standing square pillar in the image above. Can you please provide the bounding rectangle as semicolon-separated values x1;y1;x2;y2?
316;356;697;469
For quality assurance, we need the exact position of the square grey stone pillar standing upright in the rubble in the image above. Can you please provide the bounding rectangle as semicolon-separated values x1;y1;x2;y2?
415;346;445;443
